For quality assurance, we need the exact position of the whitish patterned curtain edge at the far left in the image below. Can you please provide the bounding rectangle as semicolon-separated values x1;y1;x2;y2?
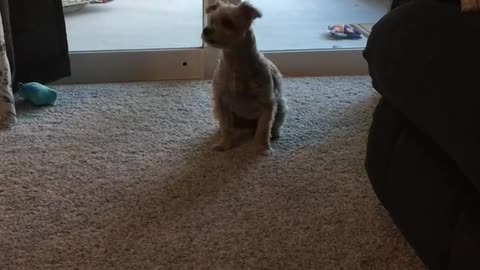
0;11;17;129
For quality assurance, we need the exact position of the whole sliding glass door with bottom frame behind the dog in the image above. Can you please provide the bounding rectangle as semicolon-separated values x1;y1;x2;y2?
63;0;388;82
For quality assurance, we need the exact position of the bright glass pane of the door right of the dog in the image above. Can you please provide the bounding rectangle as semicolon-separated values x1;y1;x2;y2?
246;0;390;51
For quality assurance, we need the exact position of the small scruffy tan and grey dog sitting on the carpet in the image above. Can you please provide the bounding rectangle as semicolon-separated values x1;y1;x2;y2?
202;1;287;154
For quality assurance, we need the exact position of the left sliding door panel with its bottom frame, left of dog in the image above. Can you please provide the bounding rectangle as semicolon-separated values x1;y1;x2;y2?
62;0;204;83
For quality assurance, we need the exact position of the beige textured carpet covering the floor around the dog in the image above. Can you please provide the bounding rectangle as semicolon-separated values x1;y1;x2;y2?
0;77;422;270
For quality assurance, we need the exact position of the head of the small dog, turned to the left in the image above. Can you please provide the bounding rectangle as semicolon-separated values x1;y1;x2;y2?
202;1;262;49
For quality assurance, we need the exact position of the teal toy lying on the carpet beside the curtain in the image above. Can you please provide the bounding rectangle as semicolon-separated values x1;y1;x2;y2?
18;82;57;106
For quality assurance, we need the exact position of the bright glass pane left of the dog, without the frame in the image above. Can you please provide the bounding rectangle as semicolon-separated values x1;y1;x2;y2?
63;0;203;52
